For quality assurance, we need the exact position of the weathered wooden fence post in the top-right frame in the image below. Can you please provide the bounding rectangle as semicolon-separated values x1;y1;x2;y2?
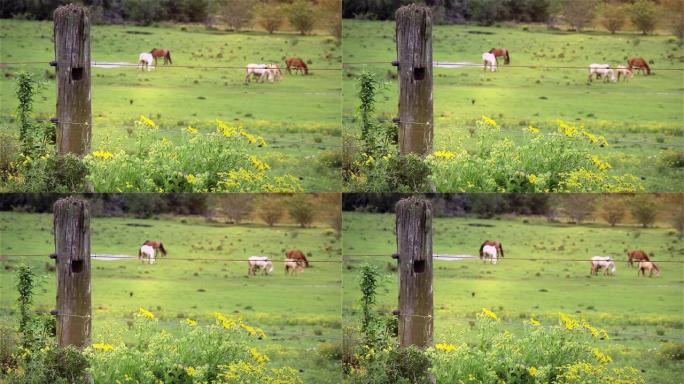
395;4;433;156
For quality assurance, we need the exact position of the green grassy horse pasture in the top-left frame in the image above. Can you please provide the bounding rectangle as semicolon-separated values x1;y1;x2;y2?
0;20;341;191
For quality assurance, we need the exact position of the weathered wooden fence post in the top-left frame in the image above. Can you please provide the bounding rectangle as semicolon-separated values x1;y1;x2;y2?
50;4;92;156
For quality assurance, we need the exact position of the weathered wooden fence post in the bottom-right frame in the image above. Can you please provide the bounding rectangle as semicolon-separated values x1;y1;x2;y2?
396;197;433;348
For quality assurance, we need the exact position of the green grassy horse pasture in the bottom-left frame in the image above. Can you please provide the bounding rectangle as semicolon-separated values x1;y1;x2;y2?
0;212;341;383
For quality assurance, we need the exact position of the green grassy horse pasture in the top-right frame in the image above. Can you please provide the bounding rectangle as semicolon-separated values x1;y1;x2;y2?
343;20;684;191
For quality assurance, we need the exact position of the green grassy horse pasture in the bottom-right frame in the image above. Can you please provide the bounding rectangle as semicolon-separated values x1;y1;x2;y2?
343;212;684;383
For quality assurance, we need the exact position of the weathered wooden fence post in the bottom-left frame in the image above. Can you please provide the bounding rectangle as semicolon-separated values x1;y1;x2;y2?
50;197;92;347
